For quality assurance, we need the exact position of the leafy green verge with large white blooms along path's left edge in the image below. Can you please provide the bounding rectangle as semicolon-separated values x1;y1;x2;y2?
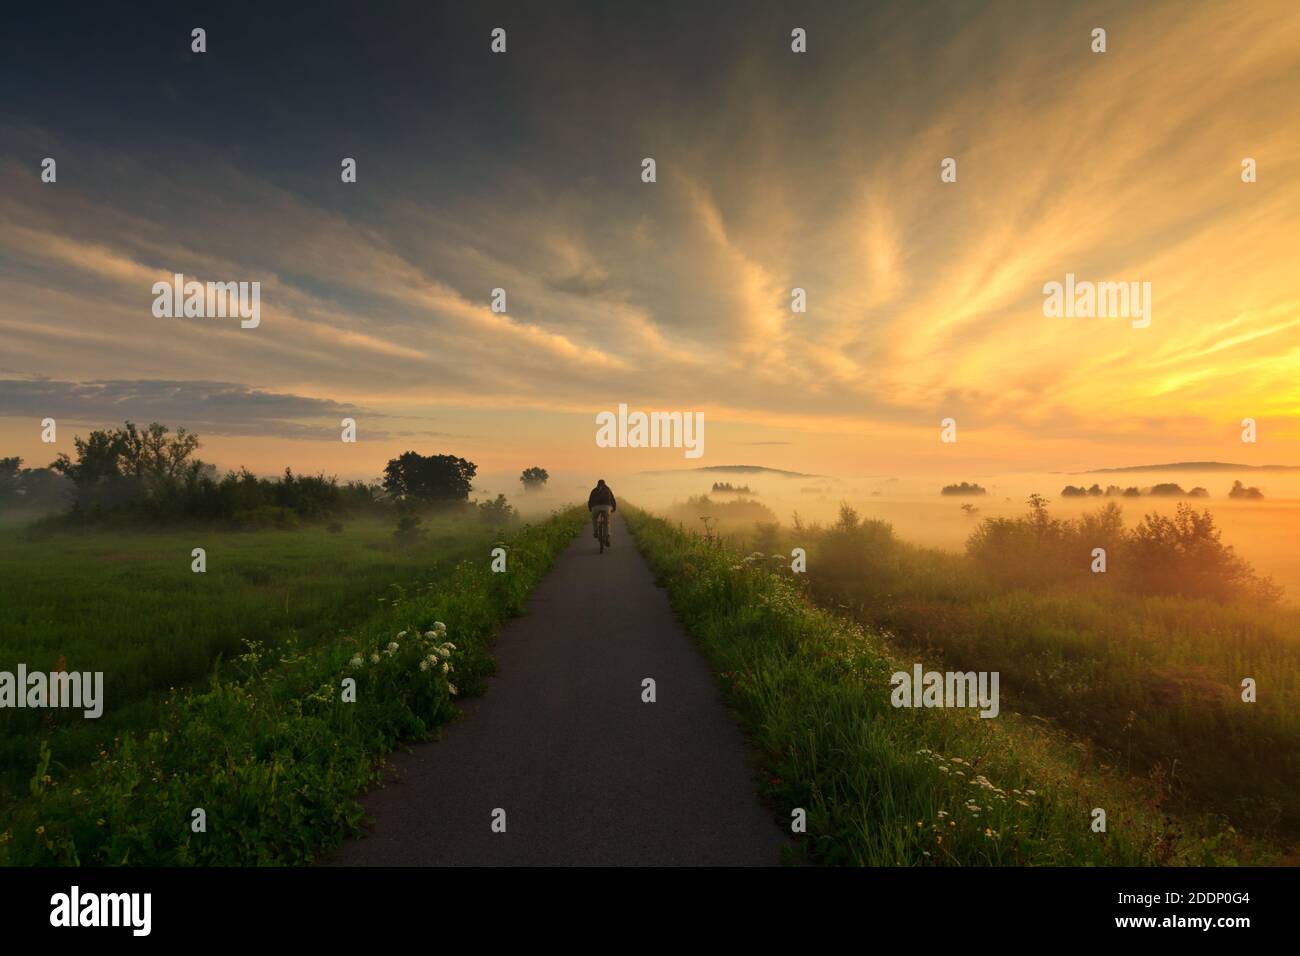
0;509;586;865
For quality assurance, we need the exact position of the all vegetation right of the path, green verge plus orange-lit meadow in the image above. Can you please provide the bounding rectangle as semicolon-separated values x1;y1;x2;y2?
628;502;1284;865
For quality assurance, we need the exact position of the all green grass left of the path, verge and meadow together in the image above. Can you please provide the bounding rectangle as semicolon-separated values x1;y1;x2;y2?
0;510;585;864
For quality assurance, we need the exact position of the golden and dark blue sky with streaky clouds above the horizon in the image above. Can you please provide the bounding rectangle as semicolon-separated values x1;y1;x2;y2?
0;0;1300;477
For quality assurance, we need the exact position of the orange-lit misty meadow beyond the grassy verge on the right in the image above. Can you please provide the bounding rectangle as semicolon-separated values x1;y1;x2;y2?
735;509;1300;843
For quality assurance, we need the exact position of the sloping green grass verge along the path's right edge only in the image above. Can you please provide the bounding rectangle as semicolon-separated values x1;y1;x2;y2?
628;510;1279;866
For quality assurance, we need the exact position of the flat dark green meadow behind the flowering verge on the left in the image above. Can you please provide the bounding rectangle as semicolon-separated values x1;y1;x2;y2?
0;515;498;801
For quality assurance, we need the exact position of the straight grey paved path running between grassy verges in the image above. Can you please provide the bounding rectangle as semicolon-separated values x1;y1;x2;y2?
328;514;784;866
